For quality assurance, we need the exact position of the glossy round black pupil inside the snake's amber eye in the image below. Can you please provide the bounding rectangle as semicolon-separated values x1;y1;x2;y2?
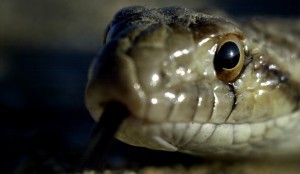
214;41;240;70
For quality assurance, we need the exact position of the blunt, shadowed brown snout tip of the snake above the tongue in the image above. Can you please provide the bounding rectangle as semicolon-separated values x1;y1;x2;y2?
85;40;145;120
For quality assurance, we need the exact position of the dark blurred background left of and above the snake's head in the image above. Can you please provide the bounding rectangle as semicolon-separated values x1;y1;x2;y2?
0;0;300;173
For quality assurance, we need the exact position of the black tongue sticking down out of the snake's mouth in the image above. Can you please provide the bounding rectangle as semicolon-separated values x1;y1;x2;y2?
81;102;129;171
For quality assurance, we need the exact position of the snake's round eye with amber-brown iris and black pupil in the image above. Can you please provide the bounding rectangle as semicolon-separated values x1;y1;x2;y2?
214;35;244;82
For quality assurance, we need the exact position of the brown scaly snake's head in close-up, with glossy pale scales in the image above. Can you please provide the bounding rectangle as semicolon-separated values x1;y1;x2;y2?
85;6;300;158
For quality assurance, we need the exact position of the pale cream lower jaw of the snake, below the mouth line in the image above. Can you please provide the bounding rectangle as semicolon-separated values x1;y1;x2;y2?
117;111;300;158
